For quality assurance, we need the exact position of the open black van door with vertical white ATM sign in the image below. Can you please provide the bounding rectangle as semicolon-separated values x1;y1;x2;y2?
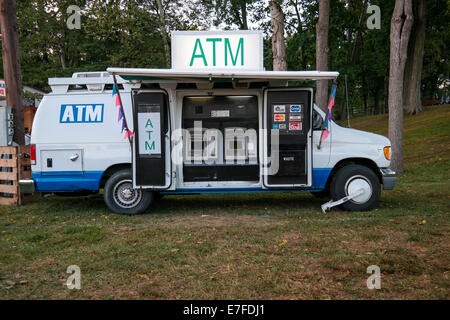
132;90;172;190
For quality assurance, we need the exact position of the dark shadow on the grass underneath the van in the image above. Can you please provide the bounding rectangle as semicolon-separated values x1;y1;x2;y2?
27;193;328;216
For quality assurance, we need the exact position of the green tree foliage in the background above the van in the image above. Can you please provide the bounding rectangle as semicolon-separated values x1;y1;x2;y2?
0;0;450;116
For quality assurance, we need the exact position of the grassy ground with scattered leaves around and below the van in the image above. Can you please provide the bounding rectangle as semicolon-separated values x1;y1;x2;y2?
0;106;450;299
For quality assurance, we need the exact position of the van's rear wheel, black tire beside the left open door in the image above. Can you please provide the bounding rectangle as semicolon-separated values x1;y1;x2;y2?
104;169;153;215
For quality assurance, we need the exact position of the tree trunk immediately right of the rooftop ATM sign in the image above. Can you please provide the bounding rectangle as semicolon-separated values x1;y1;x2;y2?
270;0;287;71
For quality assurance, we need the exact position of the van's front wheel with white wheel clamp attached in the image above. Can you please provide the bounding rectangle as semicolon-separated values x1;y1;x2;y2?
330;165;381;211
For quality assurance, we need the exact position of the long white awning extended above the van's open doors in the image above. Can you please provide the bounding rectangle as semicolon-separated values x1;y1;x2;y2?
107;68;339;81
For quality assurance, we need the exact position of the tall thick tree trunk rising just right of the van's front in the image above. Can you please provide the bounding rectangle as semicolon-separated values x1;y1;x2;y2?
388;0;414;172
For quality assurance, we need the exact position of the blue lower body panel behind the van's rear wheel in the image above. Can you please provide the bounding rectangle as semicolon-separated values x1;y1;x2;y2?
32;171;103;192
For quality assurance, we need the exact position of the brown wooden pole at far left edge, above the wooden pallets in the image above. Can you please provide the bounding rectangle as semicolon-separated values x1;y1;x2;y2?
0;0;25;145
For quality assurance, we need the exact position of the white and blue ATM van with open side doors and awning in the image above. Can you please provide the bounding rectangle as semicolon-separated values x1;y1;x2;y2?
21;68;396;214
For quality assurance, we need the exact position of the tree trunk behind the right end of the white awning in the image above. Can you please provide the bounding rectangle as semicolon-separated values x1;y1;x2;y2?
316;0;330;112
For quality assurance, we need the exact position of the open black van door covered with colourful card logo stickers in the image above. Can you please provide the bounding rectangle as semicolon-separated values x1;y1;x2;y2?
263;87;313;189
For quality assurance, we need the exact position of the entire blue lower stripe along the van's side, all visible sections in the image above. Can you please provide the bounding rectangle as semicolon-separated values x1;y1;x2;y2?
32;168;332;193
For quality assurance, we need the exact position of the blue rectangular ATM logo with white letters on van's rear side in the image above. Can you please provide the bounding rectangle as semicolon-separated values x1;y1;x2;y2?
59;104;104;123
